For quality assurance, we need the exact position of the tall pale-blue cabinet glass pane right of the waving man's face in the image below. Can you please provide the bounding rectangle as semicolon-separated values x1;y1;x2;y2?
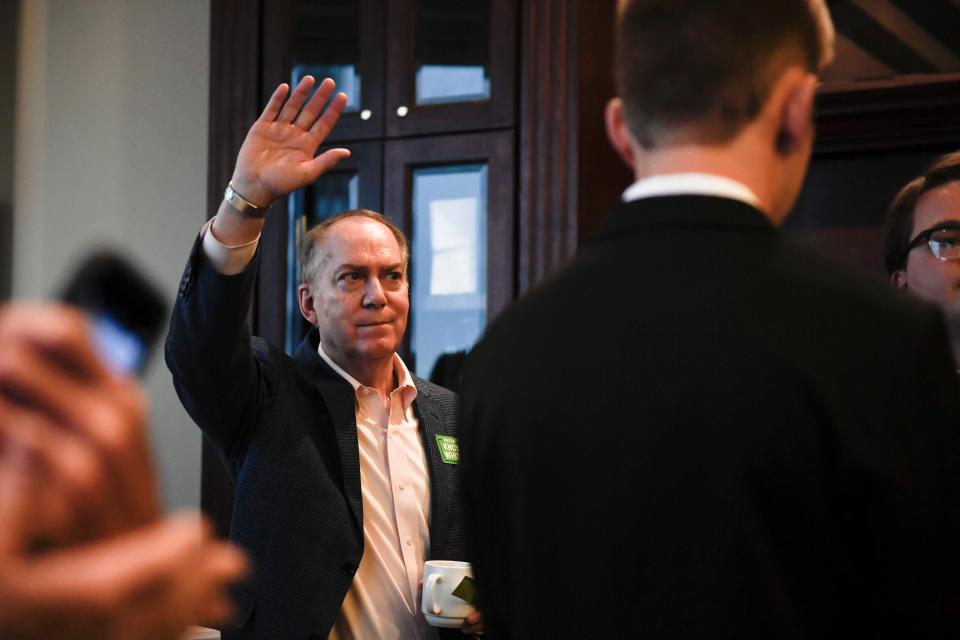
410;164;487;377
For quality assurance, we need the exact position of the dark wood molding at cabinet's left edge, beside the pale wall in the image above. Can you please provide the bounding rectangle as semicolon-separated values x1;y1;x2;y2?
200;0;261;537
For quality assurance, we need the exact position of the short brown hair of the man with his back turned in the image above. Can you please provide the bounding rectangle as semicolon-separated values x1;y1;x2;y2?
614;0;833;149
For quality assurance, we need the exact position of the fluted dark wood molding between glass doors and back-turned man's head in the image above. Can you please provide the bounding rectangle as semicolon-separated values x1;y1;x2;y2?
517;0;632;292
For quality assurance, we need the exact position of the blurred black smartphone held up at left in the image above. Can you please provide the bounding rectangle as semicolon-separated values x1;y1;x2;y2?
60;251;167;375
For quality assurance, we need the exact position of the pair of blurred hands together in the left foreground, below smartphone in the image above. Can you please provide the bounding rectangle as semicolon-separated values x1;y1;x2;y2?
0;306;246;639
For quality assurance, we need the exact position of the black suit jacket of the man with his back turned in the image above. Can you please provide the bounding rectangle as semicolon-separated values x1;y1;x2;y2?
461;196;960;640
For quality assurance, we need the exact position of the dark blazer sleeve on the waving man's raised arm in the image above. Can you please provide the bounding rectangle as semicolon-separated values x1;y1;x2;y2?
166;238;268;458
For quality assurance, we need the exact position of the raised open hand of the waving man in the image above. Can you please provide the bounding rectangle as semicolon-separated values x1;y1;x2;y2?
232;76;350;207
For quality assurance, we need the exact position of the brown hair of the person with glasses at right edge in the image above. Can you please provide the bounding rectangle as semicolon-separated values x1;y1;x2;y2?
883;151;960;275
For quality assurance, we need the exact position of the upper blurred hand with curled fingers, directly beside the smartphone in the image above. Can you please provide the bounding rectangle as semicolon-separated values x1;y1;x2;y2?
0;305;160;544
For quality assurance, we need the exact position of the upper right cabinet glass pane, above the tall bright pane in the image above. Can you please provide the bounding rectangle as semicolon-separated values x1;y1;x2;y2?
415;0;490;104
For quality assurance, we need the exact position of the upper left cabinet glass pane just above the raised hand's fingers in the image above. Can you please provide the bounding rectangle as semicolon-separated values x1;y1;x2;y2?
290;0;361;112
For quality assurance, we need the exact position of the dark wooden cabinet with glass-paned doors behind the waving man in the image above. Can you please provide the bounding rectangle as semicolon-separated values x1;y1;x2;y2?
201;0;630;533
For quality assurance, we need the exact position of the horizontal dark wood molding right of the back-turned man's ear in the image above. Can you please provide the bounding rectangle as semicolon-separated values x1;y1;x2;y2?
814;73;960;156
